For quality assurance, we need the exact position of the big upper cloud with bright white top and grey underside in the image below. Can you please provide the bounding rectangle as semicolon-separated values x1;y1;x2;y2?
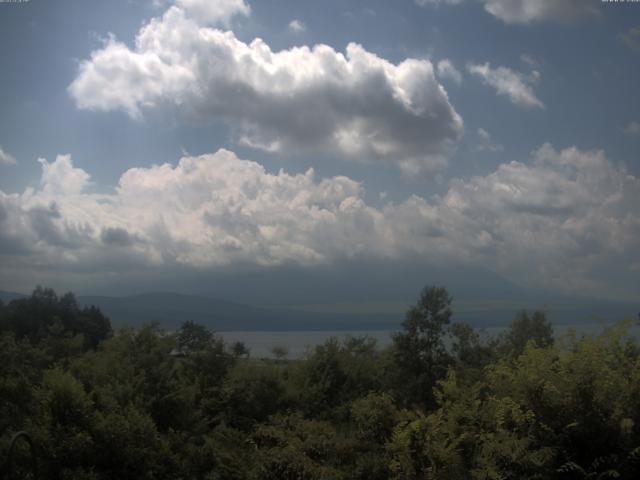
69;7;463;173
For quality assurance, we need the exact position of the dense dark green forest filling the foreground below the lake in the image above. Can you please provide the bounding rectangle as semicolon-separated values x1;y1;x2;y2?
0;287;640;480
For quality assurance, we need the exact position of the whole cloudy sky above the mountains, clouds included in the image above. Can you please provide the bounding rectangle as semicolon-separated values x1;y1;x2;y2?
0;0;640;300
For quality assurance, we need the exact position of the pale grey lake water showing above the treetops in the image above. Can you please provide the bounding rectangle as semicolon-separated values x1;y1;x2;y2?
219;323;640;358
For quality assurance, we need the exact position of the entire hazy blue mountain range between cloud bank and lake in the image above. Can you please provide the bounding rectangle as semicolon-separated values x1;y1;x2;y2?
0;268;639;331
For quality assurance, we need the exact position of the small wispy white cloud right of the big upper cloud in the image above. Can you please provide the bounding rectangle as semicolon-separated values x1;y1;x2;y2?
467;62;544;108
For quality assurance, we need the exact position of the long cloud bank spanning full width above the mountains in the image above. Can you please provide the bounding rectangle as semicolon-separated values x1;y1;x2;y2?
0;145;640;296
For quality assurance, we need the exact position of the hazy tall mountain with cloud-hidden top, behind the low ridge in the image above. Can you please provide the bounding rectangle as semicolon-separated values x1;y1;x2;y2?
194;260;531;306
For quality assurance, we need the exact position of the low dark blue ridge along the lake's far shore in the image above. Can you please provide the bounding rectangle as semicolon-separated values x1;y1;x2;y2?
72;293;636;331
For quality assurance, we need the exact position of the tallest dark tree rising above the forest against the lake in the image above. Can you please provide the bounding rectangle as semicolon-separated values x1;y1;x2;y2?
393;286;452;406
